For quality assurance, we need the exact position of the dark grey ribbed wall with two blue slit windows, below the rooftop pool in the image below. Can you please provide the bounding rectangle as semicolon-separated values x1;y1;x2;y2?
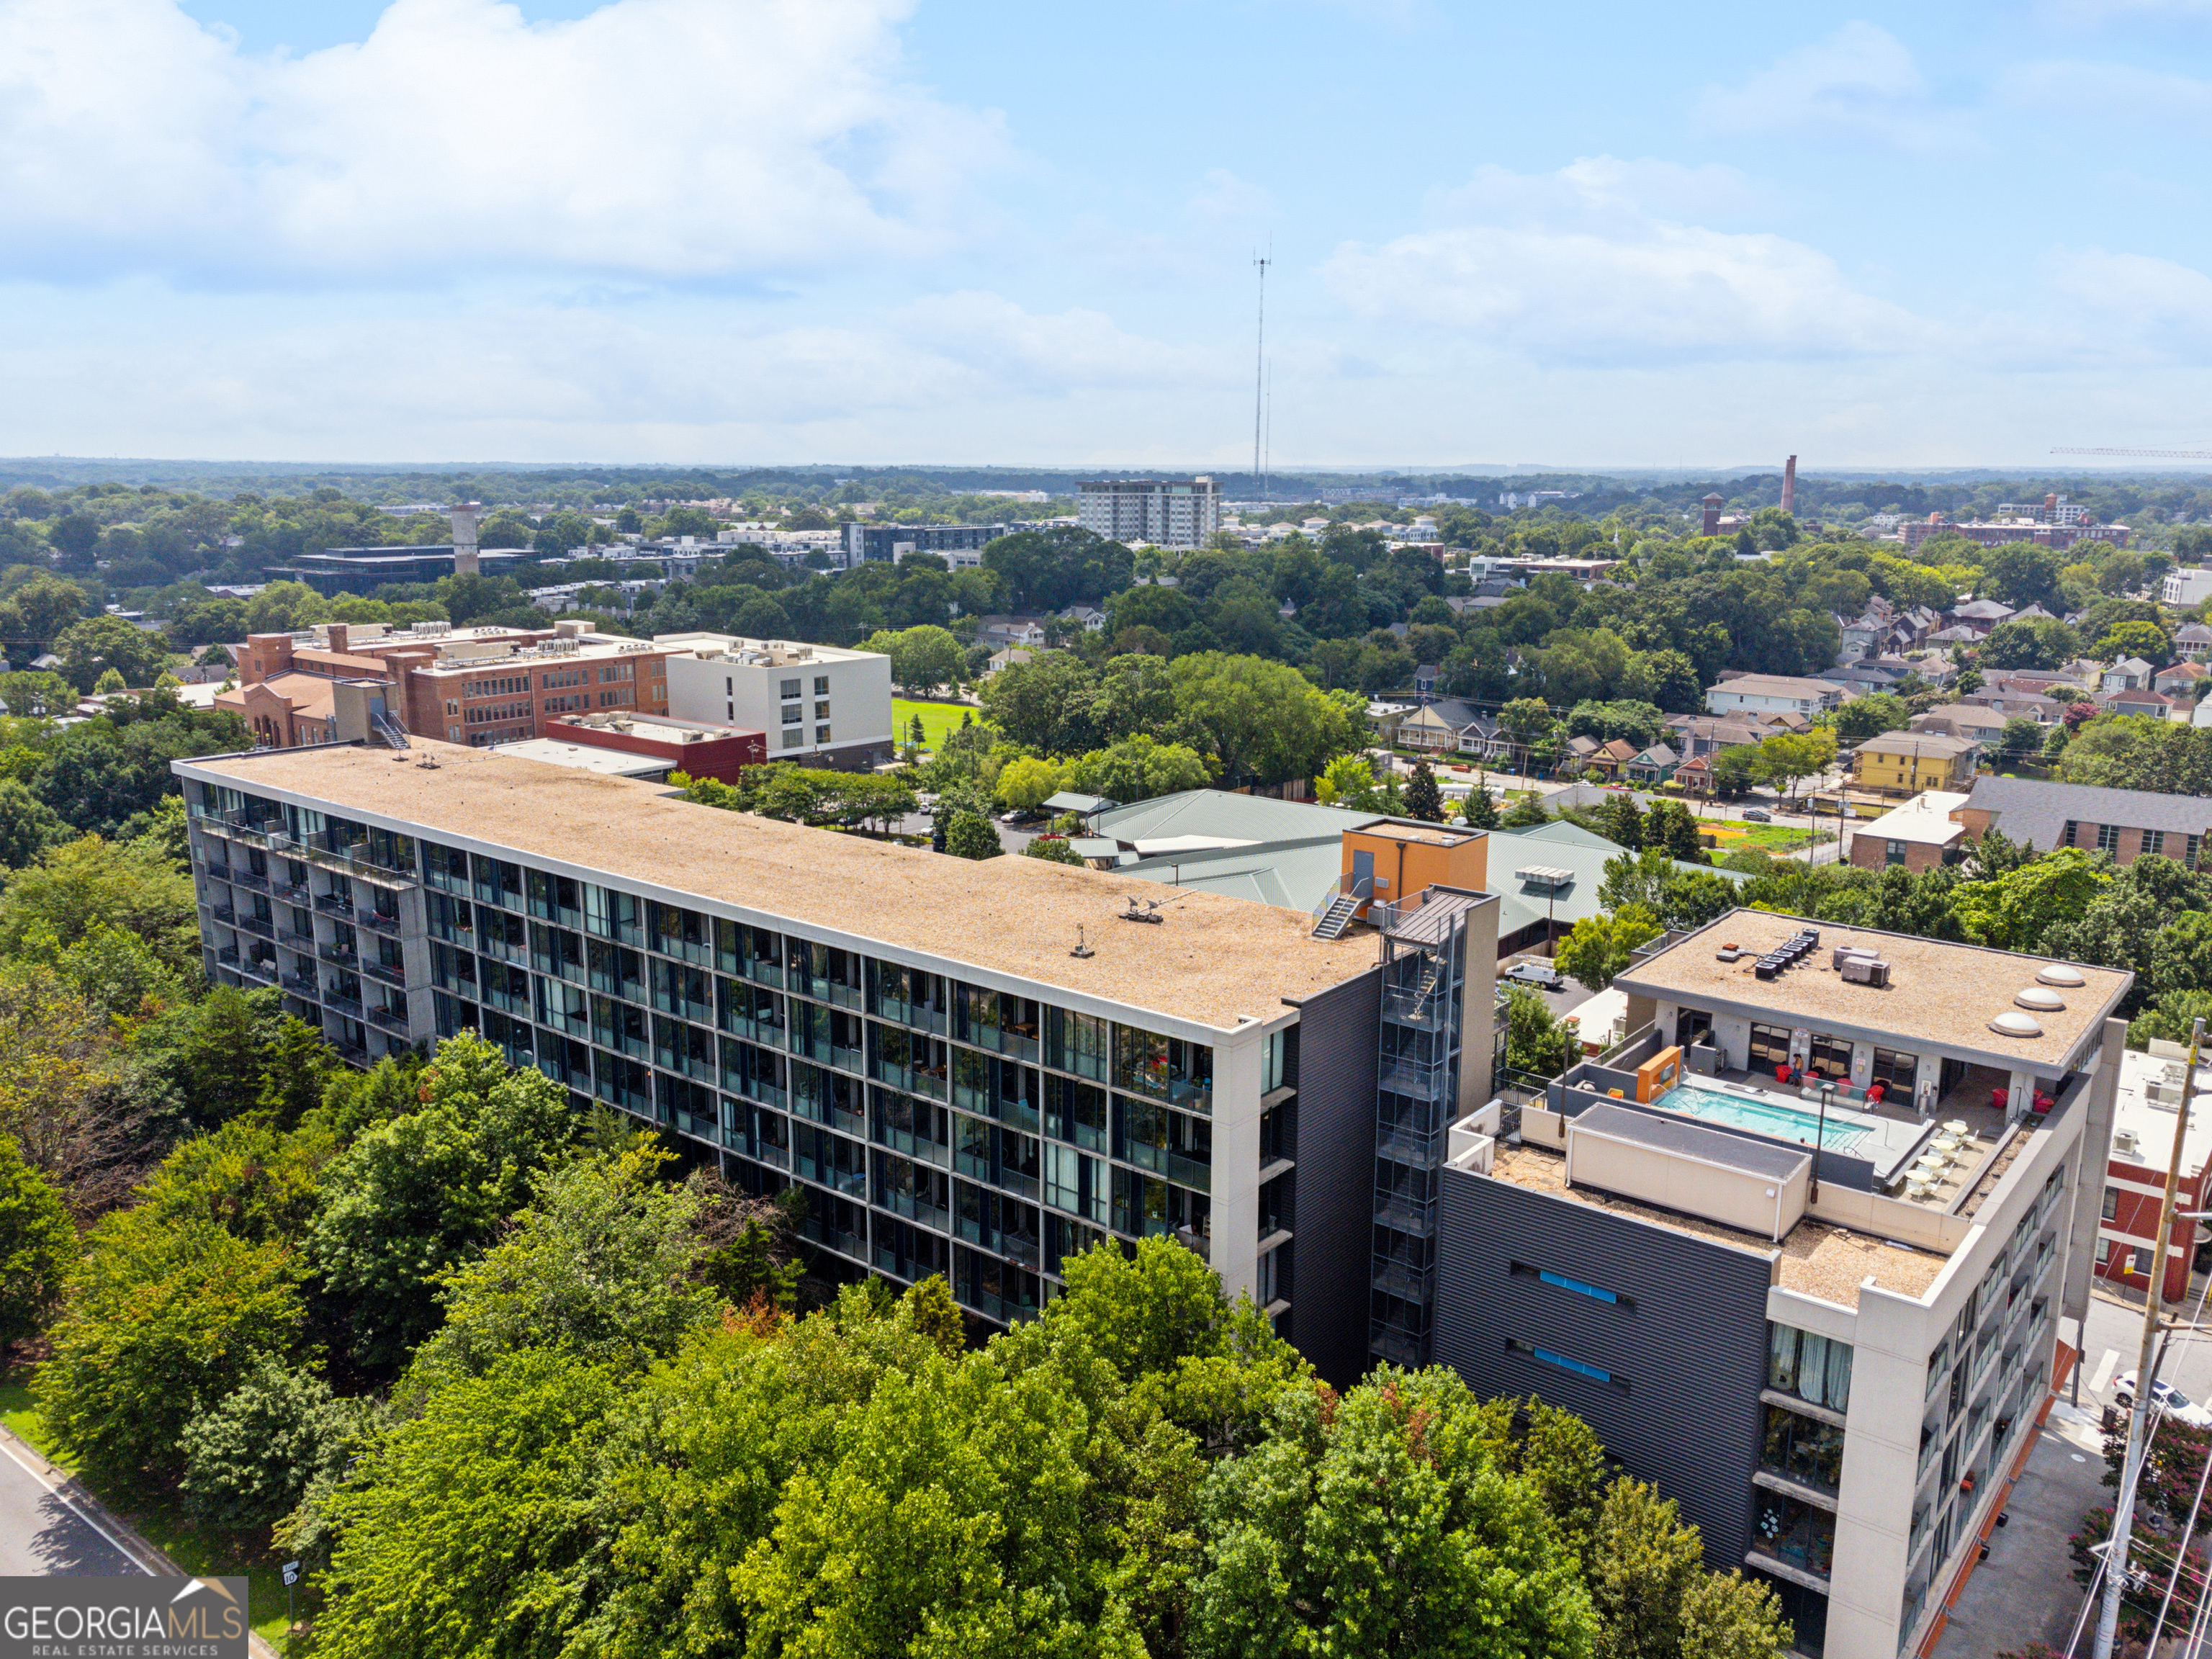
1436;1170;1770;1566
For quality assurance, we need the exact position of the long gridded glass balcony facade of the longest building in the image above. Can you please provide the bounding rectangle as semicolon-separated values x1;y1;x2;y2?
192;790;1230;1318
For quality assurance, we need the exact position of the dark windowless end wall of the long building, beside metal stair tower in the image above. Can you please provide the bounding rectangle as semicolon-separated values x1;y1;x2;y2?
1287;966;1382;1387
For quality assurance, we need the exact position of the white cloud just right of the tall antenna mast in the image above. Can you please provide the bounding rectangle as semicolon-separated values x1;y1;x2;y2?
1325;157;1936;363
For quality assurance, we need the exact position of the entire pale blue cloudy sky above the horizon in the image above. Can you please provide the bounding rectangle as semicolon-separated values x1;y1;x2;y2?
0;0;2212;469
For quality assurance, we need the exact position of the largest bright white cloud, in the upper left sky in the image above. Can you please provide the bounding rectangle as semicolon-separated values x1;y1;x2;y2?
0;0;1004;283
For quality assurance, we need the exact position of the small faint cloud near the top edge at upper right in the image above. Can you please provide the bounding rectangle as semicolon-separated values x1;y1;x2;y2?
1696;22;1969;150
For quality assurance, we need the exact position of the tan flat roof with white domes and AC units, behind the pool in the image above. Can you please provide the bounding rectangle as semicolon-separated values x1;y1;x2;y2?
1615;909;2134;1073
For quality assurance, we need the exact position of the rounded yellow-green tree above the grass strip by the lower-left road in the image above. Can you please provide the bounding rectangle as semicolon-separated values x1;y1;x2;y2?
31;1210;305;1480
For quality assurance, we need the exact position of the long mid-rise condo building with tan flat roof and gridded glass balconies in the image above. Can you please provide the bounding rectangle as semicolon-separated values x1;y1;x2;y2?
177;739;1496;1380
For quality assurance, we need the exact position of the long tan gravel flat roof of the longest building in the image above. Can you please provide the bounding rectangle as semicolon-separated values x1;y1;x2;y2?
177;737;1376;1031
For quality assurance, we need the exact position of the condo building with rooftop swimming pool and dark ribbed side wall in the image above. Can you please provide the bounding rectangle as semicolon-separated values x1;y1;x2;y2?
1436;912;2130;1659
